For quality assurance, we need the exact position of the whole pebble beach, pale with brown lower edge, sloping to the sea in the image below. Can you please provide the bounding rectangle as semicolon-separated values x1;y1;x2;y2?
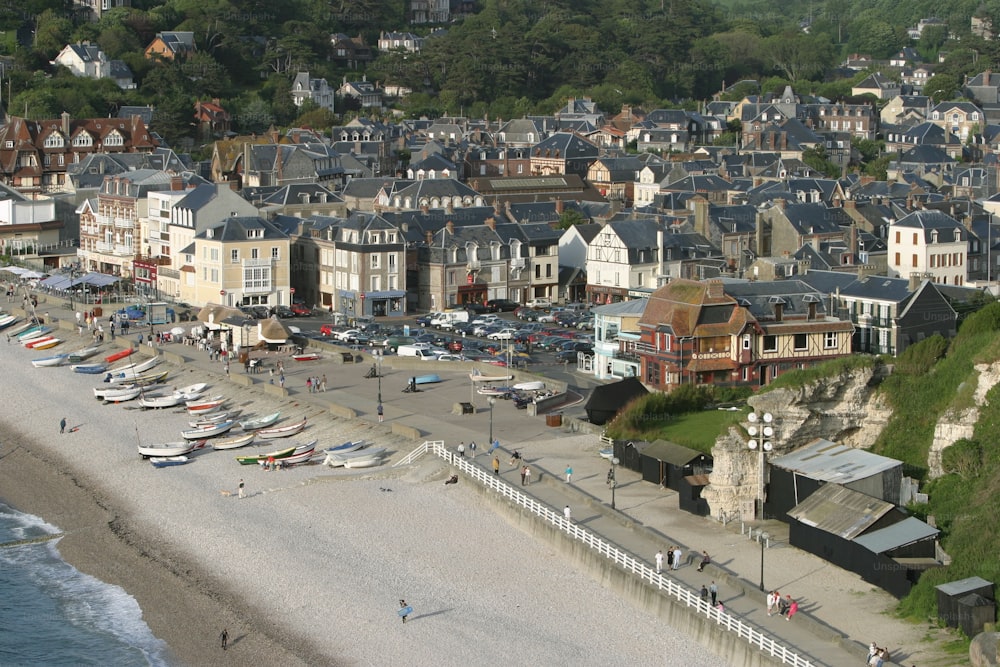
0;341;725;667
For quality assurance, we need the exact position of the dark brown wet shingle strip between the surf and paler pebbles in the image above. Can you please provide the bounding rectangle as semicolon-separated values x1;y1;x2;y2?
0;426;315;665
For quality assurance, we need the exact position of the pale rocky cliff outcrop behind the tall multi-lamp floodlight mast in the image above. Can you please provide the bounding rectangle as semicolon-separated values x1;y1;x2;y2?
702;363;892;516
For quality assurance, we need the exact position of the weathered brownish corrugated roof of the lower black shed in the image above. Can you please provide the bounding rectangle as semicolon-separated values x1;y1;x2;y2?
788;484;893;540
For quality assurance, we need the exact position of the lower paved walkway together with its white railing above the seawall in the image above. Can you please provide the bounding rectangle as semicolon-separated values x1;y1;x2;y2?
395;441;866;667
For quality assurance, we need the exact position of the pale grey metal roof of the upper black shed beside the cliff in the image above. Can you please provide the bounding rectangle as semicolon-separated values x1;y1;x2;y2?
770;438;903;484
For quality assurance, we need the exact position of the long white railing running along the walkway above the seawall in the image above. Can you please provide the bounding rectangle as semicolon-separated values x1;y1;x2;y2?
395;440;812;667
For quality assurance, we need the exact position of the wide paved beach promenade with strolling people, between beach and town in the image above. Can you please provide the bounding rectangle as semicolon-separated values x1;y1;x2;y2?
1;299;952;666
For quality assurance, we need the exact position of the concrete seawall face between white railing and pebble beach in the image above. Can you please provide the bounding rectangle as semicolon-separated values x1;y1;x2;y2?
470;484;796;667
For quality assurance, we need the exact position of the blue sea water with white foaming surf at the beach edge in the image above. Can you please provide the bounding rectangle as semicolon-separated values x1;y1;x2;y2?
0;503;168;667
